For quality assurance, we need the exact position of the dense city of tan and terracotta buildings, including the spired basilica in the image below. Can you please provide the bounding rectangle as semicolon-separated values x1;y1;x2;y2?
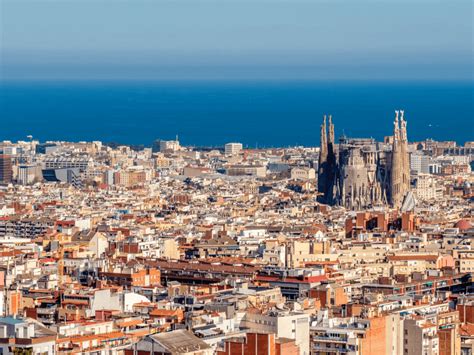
0;110;474;355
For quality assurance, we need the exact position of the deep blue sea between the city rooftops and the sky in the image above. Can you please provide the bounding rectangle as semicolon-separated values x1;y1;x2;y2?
0;81;474;147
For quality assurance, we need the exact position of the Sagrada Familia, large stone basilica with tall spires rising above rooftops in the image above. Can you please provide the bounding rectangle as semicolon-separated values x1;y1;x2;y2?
318;111;410;209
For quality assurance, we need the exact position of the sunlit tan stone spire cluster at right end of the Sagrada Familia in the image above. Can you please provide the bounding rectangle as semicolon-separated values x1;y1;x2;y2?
390;111;410;208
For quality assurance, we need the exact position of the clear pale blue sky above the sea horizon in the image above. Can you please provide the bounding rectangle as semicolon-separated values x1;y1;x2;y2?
0;0;474;80
